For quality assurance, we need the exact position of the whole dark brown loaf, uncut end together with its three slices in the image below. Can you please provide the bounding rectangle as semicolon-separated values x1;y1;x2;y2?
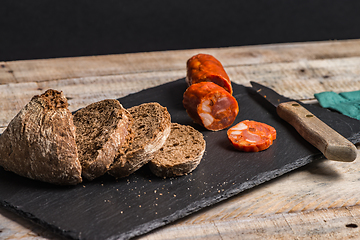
0;89;205;185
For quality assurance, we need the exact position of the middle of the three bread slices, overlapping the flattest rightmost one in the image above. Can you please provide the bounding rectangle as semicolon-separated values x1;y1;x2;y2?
109;102;171;178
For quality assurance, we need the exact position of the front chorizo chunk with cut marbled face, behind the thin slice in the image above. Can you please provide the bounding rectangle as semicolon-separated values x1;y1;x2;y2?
183;82;239;131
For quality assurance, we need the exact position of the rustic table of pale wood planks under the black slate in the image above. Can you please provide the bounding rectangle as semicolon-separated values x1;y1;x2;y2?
0;40;360;240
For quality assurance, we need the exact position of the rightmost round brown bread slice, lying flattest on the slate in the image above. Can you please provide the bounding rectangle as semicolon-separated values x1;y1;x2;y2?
149;123;206;178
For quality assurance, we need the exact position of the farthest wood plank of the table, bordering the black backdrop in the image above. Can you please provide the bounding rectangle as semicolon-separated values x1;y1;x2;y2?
0;40;360;84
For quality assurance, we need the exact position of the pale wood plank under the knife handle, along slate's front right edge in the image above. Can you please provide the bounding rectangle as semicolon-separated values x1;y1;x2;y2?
179;145;360;225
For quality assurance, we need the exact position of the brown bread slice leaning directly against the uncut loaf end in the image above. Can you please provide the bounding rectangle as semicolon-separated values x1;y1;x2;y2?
74;99;133;180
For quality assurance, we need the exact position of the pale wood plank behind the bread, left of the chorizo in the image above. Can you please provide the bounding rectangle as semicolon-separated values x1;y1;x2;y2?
0;71;184;127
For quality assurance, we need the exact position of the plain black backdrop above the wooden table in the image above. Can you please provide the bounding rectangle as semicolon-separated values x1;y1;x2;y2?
0;0;360;61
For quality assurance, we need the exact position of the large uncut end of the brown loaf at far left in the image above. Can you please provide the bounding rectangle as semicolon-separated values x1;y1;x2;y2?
0;89;82;185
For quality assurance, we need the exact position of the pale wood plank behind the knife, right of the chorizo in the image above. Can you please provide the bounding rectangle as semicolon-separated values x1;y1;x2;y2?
231;57;360;99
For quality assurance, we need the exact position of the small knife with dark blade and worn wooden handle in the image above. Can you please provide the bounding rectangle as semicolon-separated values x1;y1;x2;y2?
250;81;357;162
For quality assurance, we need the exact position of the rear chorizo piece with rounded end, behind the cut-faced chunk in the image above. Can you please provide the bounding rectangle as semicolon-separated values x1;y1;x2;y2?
186;54;233;94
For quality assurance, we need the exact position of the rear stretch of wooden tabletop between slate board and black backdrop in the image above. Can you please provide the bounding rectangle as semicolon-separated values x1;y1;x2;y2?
0;40;360;130
